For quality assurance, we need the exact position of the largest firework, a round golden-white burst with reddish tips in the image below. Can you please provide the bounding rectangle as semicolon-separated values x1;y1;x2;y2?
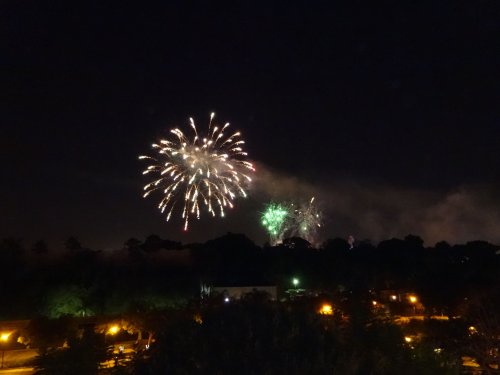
139;113;255;230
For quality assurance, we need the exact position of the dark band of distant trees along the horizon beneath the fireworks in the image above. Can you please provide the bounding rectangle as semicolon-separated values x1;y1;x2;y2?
0;233;500;319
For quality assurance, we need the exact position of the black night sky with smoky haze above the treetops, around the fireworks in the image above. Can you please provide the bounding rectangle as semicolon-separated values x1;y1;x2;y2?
0;0;500;248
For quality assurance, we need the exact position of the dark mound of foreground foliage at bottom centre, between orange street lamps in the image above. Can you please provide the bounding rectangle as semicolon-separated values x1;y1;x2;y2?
134;300;453;375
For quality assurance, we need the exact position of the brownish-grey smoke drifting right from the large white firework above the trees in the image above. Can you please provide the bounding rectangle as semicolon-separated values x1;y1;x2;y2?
252;165;500;246
